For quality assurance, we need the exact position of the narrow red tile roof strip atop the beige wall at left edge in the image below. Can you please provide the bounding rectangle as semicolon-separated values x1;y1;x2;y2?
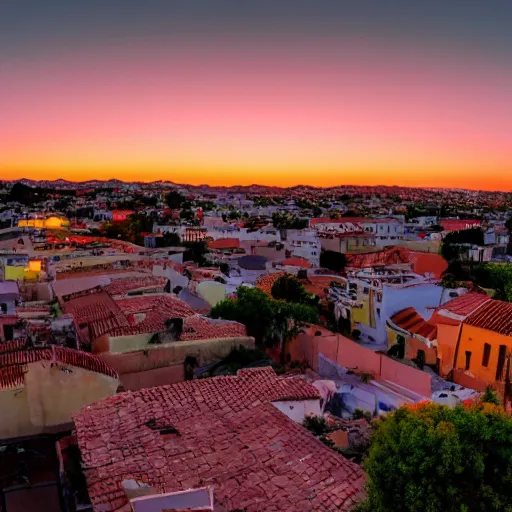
0;342;119;388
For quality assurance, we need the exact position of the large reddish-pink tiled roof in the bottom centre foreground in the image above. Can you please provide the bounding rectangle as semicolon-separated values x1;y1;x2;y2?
74;368;364;512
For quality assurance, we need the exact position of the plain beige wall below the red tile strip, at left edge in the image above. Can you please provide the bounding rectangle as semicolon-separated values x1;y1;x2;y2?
0;361;119;438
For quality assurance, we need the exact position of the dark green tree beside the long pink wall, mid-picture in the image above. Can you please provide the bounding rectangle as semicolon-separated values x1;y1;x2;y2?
210;286;319;358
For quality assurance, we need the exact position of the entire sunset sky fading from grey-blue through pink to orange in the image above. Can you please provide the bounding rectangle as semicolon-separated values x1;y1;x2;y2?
0;0;512;190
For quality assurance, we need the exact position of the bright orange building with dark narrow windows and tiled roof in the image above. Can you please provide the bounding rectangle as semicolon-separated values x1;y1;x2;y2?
455;300;512;391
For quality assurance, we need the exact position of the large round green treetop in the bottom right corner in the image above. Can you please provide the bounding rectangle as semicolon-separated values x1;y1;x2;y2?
360;403;512;512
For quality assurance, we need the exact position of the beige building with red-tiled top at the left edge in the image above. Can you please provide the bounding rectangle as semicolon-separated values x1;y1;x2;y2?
0;342;119;440
